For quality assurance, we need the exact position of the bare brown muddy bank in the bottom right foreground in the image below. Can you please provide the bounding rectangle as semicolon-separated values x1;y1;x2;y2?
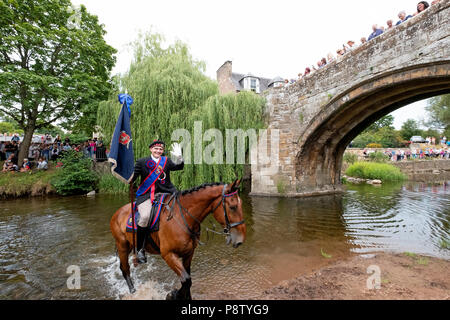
260;253;450;300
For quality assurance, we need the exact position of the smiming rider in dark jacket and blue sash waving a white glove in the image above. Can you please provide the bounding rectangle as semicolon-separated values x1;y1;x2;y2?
130;140;184;263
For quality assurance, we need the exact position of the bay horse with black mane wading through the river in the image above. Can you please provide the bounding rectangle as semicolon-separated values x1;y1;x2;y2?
110;180;247;300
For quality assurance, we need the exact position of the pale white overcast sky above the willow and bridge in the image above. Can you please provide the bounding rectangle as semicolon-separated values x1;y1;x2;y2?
72;0;434;129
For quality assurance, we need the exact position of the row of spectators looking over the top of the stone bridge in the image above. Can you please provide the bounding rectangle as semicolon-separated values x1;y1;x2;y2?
294;0;441;83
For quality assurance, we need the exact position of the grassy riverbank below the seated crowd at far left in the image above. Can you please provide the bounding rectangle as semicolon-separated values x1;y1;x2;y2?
0;167;56;199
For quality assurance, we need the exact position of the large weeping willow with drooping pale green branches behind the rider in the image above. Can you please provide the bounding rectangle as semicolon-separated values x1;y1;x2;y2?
97;34;265;189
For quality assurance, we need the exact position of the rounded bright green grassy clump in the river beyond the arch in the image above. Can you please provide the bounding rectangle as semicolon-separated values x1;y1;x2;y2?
345;162;406;181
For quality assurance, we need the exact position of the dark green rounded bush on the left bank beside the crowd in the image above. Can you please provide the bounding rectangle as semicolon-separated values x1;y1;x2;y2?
52;150;98;195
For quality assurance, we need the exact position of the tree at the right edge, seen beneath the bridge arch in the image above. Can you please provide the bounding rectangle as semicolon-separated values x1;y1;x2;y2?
425;94;450;137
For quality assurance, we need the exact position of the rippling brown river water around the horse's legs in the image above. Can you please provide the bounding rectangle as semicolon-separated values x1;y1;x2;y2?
0;181;450;299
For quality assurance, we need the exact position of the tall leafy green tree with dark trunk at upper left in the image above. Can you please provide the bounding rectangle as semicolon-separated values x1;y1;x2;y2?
0;0;116;165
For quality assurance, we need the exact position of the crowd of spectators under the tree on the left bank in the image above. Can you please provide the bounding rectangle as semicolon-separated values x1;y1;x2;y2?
0;134;108;172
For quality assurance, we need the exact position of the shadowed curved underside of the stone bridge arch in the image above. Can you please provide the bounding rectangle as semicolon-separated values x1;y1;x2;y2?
295;62;450;192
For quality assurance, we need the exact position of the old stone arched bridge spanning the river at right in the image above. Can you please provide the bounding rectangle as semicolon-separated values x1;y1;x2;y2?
252;0;450;197
